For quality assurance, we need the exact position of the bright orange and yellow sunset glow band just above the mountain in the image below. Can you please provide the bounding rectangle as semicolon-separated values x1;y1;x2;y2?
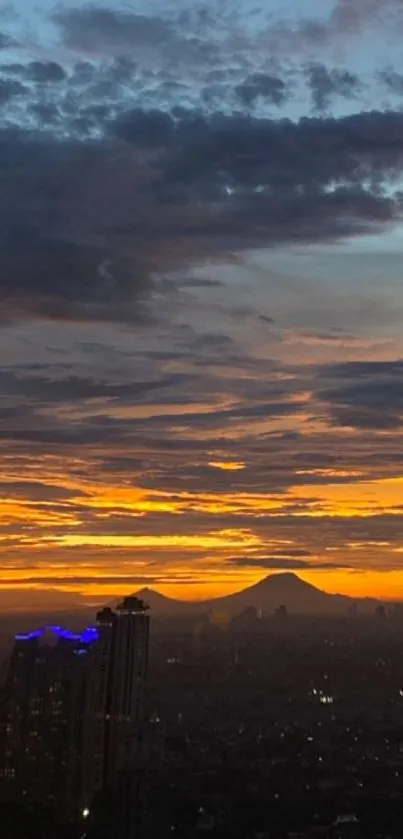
0;462;403;600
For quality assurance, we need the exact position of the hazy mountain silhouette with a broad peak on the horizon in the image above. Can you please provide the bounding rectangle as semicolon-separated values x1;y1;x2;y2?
135;572;375;616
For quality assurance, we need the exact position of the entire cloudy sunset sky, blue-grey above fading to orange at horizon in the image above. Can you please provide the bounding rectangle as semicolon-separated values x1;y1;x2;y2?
0;0;403;609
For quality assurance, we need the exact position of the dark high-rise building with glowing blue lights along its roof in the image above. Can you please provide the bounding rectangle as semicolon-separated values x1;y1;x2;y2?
0;626;96;817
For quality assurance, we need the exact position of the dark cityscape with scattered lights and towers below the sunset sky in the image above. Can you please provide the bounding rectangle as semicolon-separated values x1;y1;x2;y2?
0;574;403;839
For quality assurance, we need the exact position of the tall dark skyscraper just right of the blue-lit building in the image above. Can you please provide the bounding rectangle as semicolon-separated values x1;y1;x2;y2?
83;597;150;837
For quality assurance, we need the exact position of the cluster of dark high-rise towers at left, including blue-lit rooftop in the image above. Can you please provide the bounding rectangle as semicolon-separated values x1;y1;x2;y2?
0;597;149;839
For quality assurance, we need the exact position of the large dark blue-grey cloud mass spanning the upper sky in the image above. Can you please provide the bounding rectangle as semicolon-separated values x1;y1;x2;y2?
0;110;403;321
